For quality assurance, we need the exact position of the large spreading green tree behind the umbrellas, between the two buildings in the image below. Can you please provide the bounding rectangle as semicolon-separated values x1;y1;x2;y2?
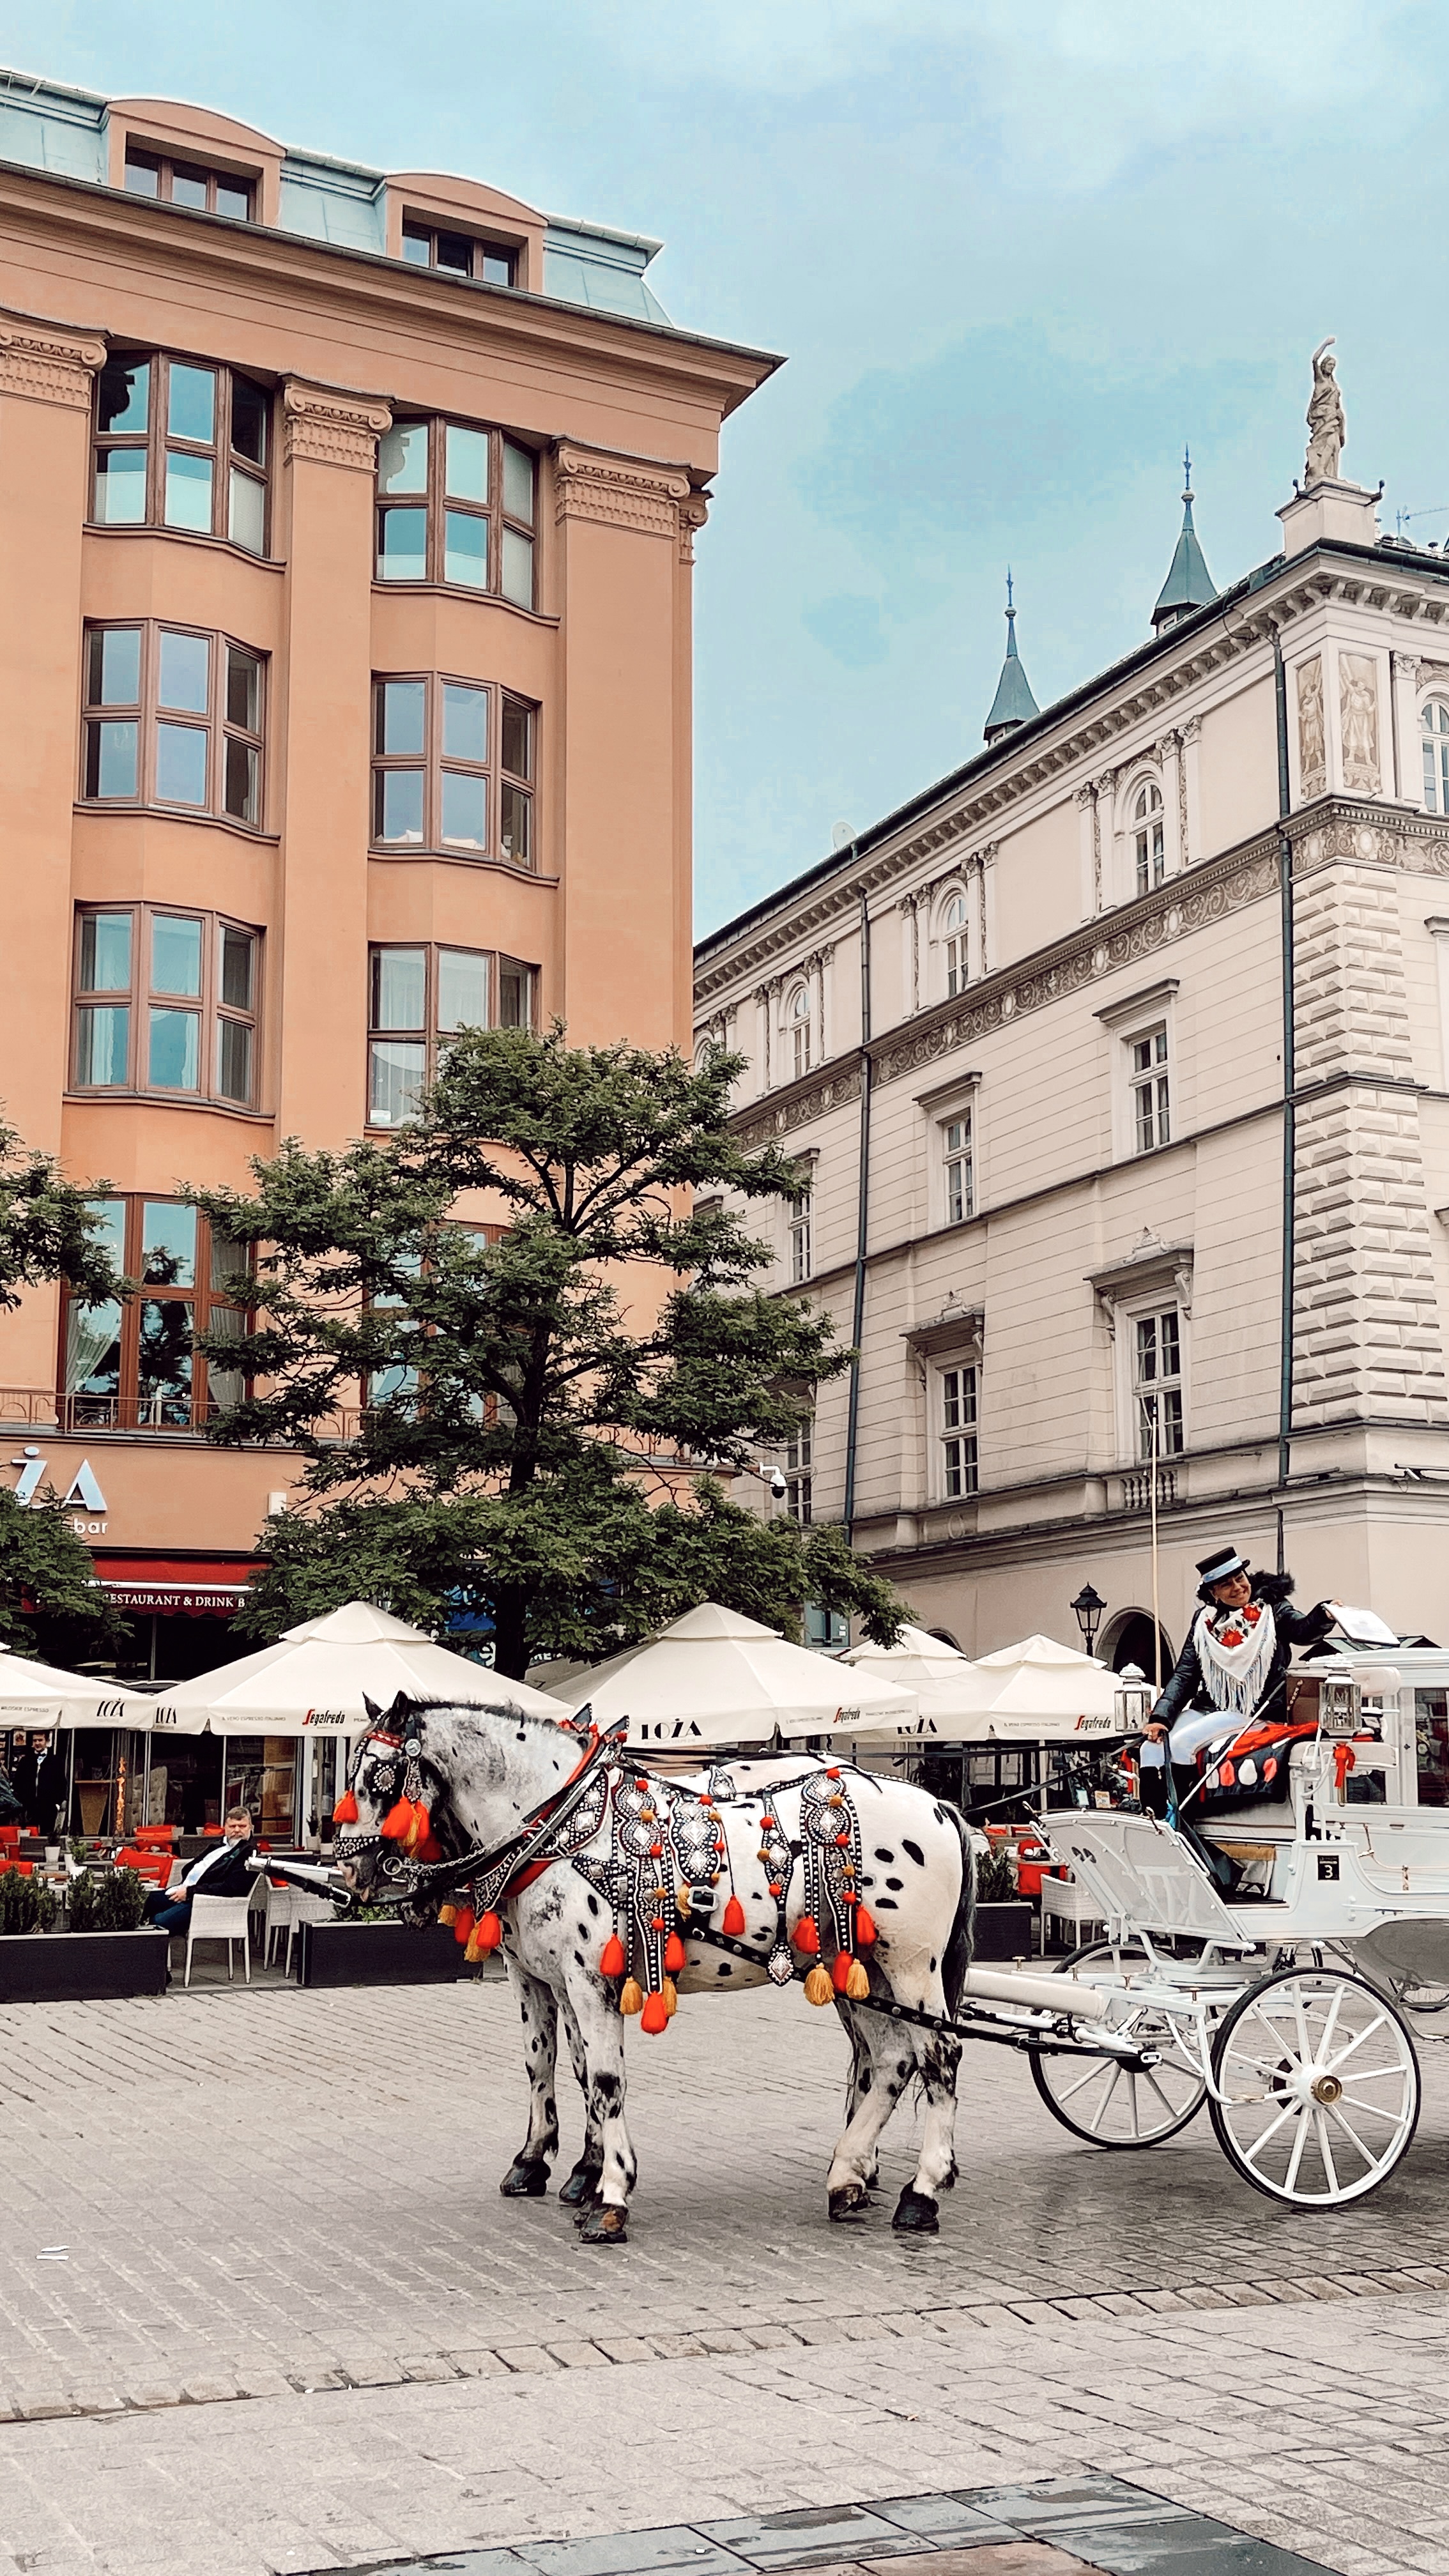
194;1028;905;1675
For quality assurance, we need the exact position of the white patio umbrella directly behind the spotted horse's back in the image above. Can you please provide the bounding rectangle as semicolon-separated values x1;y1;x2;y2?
541;1602;916;1752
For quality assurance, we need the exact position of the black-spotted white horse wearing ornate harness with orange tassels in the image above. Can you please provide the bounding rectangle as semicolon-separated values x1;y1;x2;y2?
335;1695;974;2244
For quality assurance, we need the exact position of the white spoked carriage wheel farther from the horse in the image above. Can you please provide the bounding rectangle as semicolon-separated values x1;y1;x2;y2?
1212;1968;1418;2210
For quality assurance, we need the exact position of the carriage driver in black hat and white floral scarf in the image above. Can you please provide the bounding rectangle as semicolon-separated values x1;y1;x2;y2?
1142;1545;1338;1885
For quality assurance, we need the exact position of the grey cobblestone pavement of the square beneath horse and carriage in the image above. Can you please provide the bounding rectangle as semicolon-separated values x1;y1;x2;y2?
0;1984;1449;2576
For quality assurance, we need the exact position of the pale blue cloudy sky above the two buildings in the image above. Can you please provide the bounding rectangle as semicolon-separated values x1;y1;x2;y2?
14;0;1449;930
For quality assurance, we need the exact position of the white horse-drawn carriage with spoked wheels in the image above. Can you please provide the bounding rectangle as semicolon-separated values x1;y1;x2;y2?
938;1648;1449;2207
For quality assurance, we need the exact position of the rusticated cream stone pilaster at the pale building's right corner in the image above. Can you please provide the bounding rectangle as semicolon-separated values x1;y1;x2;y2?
1294;861;1449;1427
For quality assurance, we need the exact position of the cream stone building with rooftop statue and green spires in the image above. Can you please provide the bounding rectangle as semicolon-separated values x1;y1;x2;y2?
696;376;1449;1669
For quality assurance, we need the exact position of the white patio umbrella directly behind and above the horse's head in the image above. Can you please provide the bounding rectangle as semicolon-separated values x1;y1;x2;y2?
137;1602;560;1736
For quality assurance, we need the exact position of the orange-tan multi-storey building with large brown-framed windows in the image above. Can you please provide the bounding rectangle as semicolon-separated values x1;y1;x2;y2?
0;75;776;1677
